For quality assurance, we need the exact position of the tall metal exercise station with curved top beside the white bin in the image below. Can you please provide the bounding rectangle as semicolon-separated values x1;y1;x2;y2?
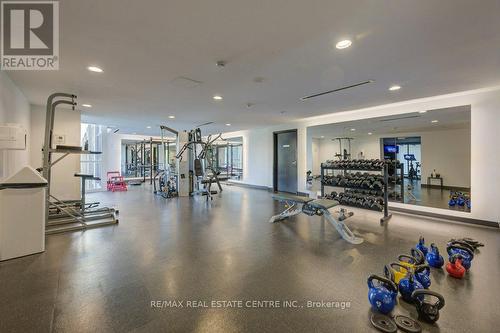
38;93;118;234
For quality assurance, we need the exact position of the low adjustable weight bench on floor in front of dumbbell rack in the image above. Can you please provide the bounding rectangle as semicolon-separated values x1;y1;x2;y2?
269;193;363;244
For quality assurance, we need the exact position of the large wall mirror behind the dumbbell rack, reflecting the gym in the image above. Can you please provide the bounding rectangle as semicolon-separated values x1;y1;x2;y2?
307;105;473;212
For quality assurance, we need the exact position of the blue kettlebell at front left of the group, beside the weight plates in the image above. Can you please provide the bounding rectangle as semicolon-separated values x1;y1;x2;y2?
367;275;398;314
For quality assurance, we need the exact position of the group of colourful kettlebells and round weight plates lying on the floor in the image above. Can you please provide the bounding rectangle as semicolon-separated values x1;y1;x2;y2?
367;236;484;332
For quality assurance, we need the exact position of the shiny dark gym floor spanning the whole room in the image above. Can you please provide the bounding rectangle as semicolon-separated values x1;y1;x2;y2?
0;185;500;332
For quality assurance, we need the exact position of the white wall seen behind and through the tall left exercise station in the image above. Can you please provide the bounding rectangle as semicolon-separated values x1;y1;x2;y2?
30;105;81;200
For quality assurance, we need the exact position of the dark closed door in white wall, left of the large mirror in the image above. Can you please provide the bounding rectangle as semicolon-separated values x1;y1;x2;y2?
274;130;297;193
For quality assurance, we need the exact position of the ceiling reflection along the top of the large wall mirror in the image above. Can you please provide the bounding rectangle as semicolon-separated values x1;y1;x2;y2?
307;105;471;139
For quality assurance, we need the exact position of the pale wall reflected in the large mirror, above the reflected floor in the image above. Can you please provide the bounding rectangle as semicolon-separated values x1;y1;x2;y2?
312;128;471;187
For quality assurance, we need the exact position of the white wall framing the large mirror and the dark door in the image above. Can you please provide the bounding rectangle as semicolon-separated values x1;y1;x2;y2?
225;87;500;222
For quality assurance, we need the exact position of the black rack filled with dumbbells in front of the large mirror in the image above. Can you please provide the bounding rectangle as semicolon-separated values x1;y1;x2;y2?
321;159;392;224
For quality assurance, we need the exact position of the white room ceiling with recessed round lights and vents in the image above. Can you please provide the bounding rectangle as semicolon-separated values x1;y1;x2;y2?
4;0;500;135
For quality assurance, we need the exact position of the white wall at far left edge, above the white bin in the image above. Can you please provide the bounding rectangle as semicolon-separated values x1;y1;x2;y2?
0;71;30;179
